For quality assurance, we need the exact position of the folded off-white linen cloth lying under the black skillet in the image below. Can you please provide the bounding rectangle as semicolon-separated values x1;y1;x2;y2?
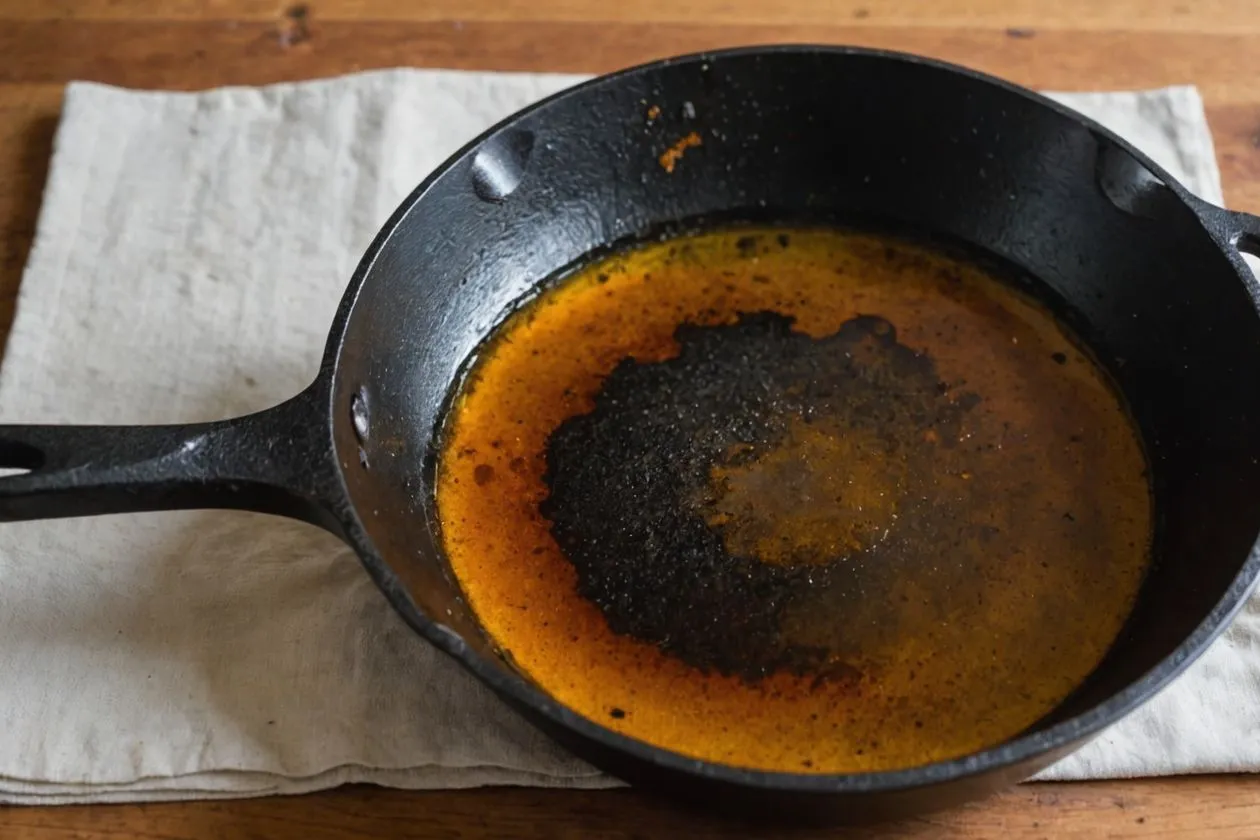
0;71;1244;802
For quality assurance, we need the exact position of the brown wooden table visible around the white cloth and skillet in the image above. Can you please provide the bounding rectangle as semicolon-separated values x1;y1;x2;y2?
0;0;1260;840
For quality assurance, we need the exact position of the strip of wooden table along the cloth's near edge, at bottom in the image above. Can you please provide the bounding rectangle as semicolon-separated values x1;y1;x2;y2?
7;777;1260;840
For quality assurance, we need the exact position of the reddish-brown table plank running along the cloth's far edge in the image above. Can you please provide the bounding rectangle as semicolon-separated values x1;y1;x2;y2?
7;22;1256;103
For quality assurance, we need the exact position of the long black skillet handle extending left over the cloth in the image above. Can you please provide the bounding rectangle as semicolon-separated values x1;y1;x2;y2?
0;387;343;533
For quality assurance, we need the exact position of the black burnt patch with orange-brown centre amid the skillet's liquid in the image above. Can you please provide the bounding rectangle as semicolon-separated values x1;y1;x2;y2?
541;312;975;680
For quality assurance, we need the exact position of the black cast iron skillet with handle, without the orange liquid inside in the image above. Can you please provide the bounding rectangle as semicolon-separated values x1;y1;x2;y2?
0;47;1260;819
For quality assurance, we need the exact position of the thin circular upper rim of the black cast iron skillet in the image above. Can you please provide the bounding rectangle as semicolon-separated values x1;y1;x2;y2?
323;43;1260;795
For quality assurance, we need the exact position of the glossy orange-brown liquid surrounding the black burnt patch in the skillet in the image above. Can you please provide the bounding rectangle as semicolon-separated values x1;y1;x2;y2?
437;229;1152;773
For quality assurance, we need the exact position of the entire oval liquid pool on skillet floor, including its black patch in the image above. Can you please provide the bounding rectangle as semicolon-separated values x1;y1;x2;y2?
437;229;1152;773
